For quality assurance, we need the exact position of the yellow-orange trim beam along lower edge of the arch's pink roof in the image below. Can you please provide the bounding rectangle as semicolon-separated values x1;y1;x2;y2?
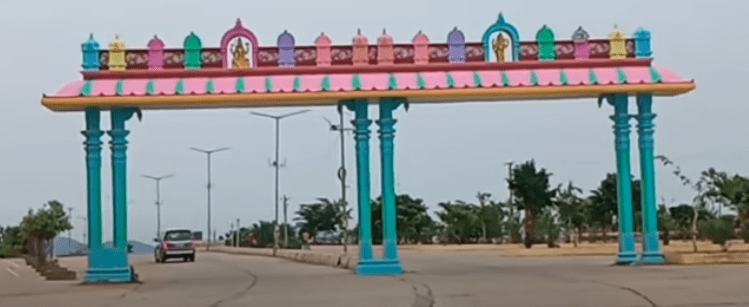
42;83;696;111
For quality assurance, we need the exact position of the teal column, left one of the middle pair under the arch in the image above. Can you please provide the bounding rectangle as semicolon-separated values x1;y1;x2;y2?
342;100;373;275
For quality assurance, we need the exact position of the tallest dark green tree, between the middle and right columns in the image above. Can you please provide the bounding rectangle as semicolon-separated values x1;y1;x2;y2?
508;160;556;248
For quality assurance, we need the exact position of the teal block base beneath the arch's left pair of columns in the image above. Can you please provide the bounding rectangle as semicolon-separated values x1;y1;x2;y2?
84;248;137;283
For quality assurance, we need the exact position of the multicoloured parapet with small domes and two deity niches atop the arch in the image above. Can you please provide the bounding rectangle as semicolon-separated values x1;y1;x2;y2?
82;14;652;71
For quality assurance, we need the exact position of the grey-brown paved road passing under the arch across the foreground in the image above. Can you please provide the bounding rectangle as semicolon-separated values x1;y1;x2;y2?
0;252;749;307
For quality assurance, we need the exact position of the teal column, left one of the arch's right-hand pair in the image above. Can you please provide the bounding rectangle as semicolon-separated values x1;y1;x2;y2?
609;94;638;264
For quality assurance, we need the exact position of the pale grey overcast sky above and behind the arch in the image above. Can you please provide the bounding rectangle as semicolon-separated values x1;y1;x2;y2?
0;0;749;245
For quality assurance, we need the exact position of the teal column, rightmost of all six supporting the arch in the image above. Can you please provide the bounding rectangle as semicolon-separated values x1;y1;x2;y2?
637;94;666;264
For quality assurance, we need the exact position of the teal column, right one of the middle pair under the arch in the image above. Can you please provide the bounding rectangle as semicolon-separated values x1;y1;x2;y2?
377;98;406;275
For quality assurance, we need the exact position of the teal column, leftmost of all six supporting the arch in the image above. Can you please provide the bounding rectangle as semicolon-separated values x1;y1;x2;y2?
81;108;104;281
